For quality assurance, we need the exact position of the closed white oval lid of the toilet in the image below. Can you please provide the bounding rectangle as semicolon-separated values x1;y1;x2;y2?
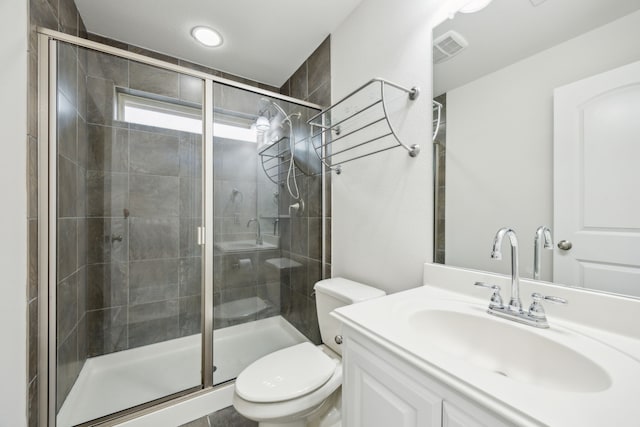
236;342;338;403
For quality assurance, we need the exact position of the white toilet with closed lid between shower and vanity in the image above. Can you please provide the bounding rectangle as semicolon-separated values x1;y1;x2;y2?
233;278;385;427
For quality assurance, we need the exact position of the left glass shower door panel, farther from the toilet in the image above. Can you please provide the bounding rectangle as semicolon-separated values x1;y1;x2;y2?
55;42;204;426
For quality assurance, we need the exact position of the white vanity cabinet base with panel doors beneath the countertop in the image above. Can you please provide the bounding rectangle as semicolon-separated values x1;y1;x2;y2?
342;325;511;427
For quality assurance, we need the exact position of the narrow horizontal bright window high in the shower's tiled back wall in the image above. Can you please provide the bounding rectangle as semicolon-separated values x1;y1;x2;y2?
115;88;258;142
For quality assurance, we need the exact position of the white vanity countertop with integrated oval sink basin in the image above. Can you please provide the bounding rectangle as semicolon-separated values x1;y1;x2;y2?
331;280;640;427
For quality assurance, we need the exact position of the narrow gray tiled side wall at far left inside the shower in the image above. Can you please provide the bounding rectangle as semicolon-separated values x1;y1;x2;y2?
56;43;87;409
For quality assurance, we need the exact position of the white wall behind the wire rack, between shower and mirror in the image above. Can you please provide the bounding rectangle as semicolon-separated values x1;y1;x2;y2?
331;0;458;292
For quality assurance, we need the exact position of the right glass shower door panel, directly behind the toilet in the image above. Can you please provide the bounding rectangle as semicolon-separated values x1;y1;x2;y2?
213;83;322;384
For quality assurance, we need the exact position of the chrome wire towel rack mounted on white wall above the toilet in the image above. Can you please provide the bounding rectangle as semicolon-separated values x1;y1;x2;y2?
307;78;420;174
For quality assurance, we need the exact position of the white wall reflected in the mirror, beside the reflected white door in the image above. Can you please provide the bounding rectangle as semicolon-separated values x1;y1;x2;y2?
445;12;640;280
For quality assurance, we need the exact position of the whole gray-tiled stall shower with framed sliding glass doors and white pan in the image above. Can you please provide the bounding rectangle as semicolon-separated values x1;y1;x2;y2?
40;32;326;426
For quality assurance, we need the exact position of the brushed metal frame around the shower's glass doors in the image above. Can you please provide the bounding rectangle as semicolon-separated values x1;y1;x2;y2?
37;28;327;427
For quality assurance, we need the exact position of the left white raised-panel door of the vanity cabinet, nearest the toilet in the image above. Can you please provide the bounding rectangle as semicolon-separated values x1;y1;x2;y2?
342;339;442;427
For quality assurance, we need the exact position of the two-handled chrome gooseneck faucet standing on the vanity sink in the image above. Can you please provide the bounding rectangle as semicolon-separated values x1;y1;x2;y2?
475;228;567;328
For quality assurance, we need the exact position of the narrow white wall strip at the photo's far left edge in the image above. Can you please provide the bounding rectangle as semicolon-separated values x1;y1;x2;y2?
0;0;28;427
